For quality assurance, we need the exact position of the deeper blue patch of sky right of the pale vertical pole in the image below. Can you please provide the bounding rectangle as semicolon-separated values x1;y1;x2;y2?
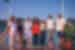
64;0;75;18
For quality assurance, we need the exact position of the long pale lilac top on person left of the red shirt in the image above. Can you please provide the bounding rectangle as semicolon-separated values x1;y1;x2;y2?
24;21;32;39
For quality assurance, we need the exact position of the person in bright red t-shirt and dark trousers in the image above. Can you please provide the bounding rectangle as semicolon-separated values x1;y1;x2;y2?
32;17;40;47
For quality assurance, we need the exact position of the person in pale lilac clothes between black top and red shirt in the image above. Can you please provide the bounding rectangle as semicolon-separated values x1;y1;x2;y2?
24;17;32;48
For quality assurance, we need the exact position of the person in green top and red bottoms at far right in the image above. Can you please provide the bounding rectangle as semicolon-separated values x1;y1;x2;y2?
64;24;72;49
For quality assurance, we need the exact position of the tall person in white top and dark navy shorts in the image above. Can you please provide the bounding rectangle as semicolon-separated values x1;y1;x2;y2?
55;14;65;48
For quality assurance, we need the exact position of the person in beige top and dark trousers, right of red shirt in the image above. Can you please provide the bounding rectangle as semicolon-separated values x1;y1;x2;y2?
40;20;46;47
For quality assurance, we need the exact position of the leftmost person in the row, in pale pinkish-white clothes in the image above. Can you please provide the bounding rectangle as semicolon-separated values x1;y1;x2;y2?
6;16;16;50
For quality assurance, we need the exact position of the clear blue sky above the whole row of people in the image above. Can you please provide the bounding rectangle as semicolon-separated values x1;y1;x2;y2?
0;0;75;19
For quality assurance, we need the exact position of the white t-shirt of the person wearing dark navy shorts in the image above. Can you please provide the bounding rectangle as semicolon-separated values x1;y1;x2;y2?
56;18;66;31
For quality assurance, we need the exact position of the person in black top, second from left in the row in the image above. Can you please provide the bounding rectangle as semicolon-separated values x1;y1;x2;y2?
17;18;23;50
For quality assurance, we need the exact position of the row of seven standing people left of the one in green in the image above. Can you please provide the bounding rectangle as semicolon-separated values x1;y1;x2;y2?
5;15;66;50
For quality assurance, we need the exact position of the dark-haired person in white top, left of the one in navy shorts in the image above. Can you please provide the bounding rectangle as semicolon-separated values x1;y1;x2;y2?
46;16;54;47
